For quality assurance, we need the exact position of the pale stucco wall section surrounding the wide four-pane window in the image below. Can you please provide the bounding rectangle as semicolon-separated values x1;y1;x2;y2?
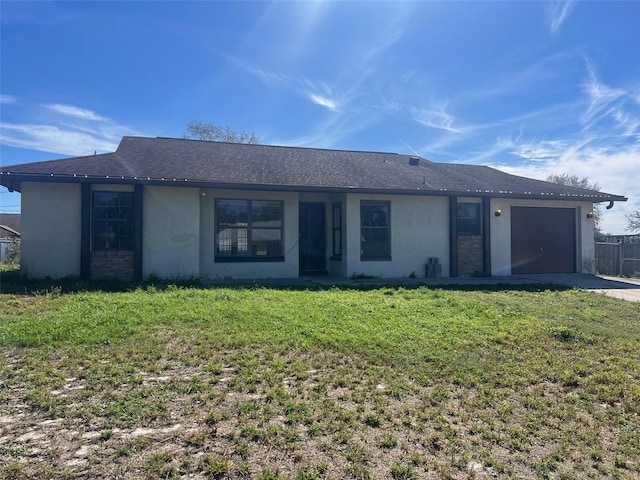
200;189;299;281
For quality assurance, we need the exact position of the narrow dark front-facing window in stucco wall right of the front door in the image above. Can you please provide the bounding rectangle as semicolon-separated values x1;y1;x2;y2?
360;200;391;260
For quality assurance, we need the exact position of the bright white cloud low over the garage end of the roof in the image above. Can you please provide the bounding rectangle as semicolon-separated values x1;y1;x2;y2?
472;86;640;233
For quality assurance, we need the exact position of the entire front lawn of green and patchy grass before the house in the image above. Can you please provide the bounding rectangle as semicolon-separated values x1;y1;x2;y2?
0;275;640;479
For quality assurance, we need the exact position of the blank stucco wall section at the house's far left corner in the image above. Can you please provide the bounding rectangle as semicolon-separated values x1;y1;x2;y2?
20;183;81;278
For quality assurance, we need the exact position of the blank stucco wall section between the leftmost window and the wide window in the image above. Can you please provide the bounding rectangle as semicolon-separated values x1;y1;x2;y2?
142;186;200;279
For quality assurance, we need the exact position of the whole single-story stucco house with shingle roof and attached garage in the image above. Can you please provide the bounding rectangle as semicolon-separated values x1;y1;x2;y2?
0;137;626;281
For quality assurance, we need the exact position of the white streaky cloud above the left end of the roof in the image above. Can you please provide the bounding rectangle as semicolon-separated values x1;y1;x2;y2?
0;103;136;155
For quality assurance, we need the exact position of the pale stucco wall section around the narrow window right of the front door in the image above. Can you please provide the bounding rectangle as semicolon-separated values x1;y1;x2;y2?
344;194;449;278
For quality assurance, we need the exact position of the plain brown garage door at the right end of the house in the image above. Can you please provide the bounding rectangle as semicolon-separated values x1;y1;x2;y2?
511;207;576;273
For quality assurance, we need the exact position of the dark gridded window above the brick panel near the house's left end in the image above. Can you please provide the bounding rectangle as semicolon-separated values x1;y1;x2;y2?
91;192;133;250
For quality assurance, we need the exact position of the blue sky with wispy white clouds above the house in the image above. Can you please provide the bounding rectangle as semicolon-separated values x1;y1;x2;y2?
0;0;640;233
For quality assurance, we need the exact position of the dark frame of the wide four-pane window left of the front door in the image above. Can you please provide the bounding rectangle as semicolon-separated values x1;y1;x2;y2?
214;198;284;263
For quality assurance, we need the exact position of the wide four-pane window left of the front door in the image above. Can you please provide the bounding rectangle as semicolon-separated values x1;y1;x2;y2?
216;200;283;261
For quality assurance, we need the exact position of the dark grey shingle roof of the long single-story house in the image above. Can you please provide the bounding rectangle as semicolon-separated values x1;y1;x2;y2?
0;137;626;202
